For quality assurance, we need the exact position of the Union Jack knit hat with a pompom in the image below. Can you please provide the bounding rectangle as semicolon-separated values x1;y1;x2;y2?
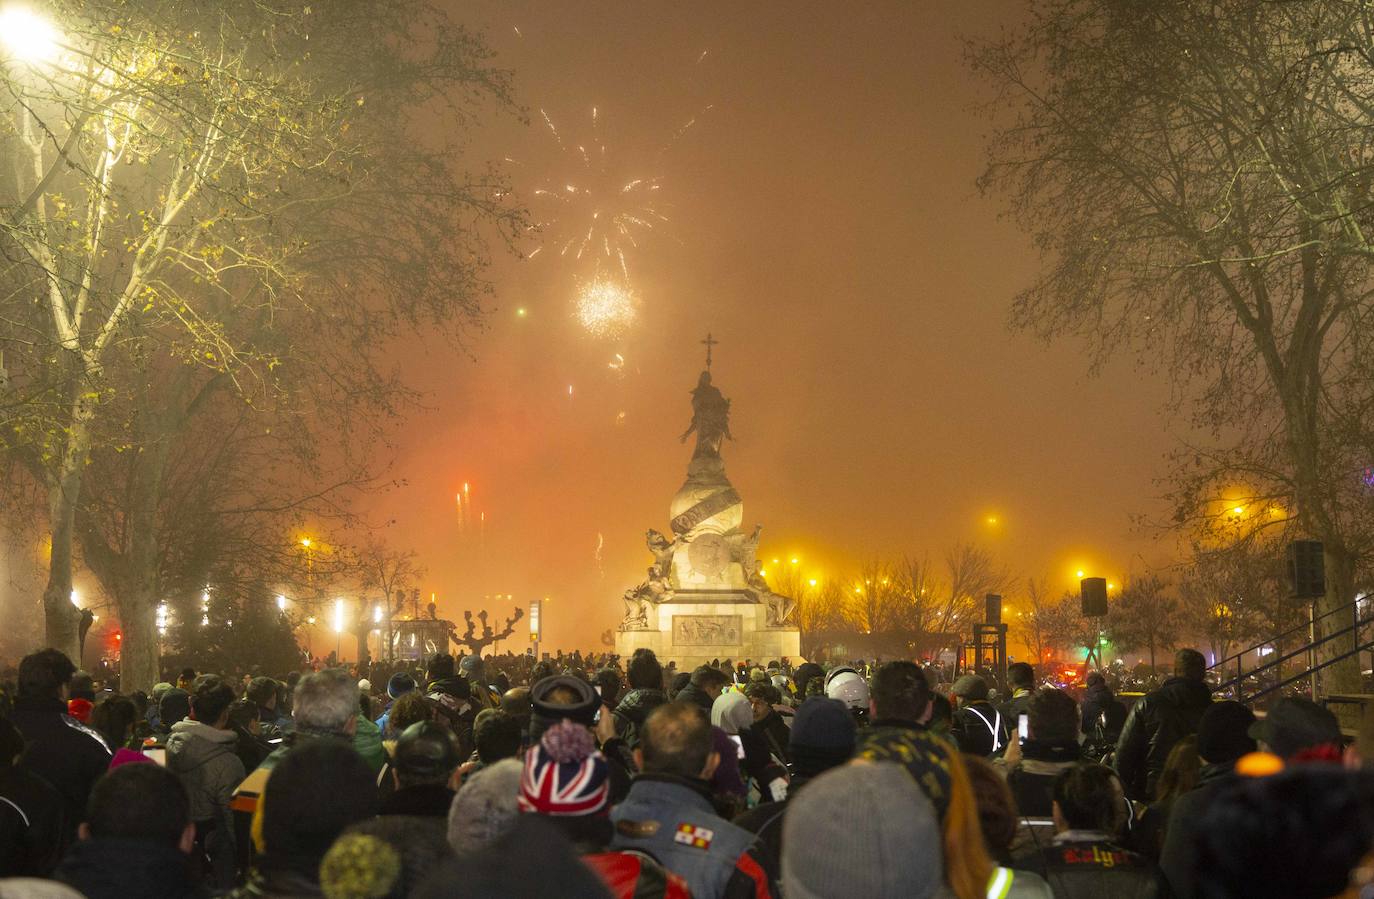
519;720;610;815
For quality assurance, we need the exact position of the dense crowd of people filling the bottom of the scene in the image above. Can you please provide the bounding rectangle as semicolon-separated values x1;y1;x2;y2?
0;649;1374;899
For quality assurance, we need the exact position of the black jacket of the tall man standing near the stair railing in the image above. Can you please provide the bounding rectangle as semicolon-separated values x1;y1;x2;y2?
1116;678;1212;800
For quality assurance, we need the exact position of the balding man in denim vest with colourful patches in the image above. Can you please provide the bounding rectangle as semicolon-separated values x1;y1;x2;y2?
611;701;771;899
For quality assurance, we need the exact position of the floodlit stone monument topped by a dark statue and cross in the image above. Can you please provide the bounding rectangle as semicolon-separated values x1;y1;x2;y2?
616;334;801;671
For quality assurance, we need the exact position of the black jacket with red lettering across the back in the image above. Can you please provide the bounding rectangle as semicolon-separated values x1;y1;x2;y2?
1015;830;1169;899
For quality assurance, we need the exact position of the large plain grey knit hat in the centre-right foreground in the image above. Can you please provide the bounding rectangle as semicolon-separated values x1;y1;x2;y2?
782;763;944;899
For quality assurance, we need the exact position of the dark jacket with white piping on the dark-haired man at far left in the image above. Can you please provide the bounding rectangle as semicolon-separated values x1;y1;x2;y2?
10;697;110;837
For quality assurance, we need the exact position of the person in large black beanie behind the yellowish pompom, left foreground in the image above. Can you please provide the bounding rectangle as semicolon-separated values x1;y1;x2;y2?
228;736;378;899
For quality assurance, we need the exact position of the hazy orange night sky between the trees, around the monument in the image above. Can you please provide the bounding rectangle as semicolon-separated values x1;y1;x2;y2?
368;0;1175;649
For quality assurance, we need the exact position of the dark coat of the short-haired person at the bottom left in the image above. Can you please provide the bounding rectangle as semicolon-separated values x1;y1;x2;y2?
54;839;203;899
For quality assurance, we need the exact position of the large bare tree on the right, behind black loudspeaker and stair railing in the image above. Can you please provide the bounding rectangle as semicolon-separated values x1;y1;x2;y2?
969;0;1374;689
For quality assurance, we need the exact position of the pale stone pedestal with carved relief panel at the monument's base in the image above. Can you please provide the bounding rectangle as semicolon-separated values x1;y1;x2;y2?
616;591;801;671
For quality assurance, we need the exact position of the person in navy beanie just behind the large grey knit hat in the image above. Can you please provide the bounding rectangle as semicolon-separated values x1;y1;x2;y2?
732;696;856;872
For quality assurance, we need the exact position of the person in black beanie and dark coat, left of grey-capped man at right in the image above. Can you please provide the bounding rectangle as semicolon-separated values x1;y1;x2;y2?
1160;700;1258;899
